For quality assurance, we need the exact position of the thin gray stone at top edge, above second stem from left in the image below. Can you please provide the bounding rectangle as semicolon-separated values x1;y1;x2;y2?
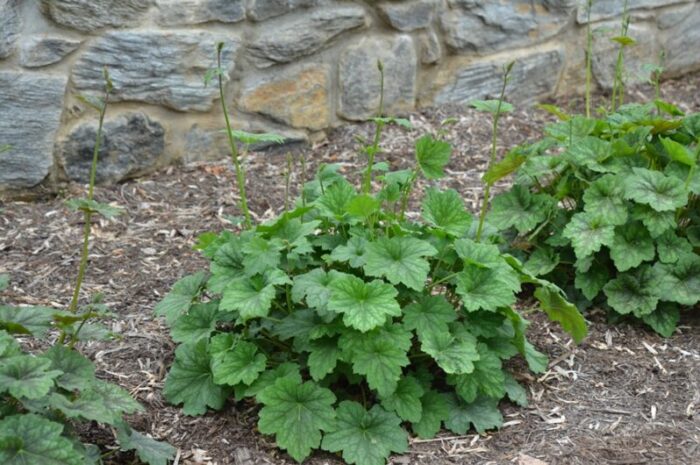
157;0;245;26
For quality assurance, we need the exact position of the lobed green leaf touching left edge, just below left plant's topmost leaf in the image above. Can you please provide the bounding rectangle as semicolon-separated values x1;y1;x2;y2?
0;355;62;399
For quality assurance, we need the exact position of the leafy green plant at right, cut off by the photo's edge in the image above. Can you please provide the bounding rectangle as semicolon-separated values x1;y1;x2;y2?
488;100;700;336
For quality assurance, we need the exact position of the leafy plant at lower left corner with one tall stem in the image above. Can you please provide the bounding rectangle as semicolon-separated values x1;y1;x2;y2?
0;70;175;465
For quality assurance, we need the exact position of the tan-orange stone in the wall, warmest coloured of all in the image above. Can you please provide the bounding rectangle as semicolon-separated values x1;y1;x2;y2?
240;65;330;130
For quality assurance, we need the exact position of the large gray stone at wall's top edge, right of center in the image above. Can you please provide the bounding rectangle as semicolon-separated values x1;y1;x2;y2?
440;0;571;54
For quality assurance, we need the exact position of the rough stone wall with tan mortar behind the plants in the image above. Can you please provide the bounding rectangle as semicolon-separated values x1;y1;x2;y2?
0;0;700;192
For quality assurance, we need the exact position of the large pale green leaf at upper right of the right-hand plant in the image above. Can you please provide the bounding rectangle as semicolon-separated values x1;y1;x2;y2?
624;168;688;212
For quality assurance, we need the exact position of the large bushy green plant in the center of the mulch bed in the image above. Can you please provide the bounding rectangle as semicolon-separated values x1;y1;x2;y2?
155;73;586;465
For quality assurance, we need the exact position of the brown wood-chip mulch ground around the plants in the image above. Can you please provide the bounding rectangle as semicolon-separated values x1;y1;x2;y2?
0;75;700;465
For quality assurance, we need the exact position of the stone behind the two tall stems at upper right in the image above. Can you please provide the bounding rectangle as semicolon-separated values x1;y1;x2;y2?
592;22;661;90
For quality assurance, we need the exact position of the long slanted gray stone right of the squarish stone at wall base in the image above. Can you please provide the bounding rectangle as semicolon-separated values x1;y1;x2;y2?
434;50;564;104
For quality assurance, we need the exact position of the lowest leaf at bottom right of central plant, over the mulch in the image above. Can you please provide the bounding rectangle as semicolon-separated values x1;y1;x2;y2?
445;396;503;434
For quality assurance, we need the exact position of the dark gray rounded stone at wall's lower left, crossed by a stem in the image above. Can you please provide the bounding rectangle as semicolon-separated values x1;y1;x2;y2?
57;113;165;184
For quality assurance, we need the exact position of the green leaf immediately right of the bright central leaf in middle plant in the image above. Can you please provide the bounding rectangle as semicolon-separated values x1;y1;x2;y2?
403;295;457;340
